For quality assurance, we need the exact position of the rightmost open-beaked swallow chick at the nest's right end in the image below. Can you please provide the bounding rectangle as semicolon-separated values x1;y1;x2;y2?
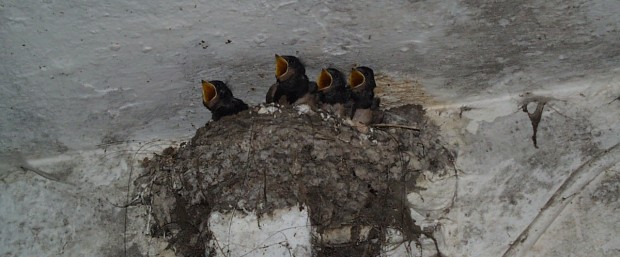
349;66;383;125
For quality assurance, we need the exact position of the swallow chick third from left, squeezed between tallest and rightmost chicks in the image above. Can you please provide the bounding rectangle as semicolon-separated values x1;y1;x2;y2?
316;68;351;117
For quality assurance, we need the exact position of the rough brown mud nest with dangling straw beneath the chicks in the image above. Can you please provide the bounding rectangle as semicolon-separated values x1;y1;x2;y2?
135;105;454;256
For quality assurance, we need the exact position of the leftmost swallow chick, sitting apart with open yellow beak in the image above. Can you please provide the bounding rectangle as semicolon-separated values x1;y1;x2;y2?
202;80;248;121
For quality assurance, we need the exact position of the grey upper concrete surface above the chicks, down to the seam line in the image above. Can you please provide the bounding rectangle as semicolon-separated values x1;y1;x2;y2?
0;0;620;153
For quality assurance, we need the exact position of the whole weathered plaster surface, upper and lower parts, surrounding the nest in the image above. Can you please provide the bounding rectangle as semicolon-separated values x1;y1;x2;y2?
0;0;620;256
